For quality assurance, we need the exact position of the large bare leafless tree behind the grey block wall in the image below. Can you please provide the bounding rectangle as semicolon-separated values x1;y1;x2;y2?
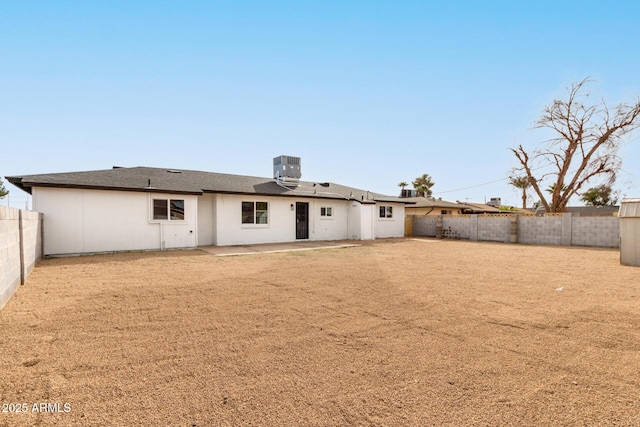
511;79;640;212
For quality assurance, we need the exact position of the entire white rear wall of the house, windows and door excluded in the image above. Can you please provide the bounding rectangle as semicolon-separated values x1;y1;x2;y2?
33;187;405;255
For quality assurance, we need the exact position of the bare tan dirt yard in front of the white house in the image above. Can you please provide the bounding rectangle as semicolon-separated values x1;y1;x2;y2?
0;239;640;427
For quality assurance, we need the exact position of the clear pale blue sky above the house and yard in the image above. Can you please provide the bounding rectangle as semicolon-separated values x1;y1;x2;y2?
0;0;640;207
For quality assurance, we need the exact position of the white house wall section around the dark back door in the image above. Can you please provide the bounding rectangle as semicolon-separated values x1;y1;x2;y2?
215;194;351;246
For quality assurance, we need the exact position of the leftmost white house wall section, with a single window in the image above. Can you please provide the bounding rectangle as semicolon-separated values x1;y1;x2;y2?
33;187;197;255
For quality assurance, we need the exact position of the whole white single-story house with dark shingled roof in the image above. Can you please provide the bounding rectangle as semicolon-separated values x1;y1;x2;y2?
6;156;407;255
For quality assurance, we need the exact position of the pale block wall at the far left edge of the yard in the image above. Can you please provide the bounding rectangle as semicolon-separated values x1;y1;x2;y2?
0;206;42;309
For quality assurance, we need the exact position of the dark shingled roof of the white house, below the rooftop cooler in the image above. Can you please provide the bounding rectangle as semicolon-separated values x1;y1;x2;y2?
6;166;411;203
